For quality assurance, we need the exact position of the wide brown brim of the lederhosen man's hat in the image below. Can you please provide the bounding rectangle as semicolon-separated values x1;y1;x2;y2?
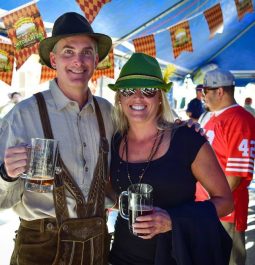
39;33;112;68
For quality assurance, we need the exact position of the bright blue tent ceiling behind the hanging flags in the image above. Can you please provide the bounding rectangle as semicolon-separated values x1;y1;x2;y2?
0;0;255;85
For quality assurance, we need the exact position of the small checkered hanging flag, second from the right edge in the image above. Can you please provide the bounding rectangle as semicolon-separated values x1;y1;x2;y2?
204;4;223;39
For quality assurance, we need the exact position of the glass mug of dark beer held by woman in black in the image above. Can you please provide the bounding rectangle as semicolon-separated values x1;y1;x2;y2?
119;183;153;235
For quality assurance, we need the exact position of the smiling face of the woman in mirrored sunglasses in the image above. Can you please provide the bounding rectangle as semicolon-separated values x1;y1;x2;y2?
119;89;161;123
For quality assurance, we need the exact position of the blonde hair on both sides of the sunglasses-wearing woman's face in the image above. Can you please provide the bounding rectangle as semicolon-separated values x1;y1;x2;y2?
112;90;174;135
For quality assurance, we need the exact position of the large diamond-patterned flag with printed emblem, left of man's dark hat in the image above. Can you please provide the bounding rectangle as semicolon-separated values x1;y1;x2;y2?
2;4;46;69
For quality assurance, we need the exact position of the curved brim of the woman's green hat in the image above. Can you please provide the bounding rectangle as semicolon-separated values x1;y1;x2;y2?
108;79;173;92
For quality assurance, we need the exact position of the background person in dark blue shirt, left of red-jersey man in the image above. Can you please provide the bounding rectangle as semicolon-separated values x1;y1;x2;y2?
186;84;205;122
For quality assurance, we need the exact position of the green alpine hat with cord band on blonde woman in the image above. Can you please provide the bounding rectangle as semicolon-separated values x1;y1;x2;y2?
108;53;172;92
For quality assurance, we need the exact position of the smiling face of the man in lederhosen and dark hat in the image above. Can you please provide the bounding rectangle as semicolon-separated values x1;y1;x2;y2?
50;35;98;90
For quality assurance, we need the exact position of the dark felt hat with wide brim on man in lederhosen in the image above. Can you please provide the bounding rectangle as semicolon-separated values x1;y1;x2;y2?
39;12;112;68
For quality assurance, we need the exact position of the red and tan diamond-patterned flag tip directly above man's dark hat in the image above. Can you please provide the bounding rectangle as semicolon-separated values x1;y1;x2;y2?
76;0;111;24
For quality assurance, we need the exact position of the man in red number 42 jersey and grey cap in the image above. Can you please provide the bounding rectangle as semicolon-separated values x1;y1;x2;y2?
197;69;255;265
